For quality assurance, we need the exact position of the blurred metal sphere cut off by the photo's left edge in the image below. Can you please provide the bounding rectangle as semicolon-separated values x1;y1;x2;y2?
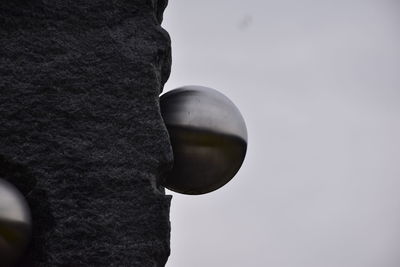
0;179;31;267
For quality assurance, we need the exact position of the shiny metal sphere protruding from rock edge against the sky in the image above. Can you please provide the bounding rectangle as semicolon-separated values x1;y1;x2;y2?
160;86;247;195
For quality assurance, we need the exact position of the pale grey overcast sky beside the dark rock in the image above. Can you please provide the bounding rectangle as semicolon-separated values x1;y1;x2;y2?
163;0;400;267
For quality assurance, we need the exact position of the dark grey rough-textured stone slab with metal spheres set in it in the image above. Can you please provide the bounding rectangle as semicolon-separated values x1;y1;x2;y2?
0;0;172;267
